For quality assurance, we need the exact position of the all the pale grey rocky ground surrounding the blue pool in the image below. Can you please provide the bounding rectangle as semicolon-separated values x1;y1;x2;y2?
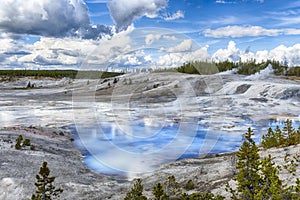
0;73;300;200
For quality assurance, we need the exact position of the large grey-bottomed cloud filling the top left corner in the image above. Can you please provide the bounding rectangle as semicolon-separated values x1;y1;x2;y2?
0;0;90;36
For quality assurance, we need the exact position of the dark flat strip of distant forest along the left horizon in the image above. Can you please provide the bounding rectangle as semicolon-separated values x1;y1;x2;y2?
0;70;124;79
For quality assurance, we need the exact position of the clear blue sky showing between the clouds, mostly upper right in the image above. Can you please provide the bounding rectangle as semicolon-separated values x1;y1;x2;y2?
86;0;300;53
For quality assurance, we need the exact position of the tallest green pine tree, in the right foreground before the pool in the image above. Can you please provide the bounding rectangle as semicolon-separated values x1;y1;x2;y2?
234;128;261;199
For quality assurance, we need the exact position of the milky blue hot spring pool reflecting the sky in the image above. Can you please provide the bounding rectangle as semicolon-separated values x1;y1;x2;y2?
69;119;300;175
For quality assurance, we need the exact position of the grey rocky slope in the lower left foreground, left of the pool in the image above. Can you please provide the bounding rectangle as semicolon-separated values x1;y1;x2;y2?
0;127;122;200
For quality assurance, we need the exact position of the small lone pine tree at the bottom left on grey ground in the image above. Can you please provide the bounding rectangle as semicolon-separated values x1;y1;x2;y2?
31;162;63;200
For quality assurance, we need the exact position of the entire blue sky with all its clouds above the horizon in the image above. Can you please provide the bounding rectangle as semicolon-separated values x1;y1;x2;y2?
0;0;300;70
